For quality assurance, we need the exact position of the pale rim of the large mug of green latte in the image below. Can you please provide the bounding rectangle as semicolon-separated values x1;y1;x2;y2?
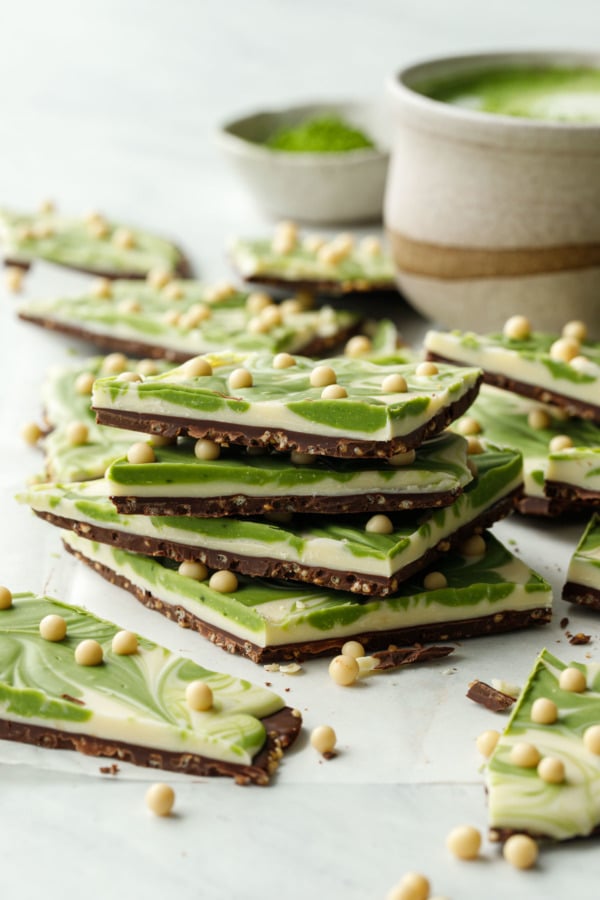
387;48;600;134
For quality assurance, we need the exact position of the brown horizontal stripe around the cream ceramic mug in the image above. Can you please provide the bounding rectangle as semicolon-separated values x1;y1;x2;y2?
388;229;600;280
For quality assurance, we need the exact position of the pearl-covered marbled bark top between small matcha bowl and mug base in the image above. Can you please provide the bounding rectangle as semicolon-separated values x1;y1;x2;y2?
229;238;395;291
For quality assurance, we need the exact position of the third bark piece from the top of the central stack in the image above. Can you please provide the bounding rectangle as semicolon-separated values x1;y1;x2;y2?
20;446;522;598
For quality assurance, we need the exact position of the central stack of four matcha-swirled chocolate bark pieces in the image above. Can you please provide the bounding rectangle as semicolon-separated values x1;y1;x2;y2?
25;352;551;661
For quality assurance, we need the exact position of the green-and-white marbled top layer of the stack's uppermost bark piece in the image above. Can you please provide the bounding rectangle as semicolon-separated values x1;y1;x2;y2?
93;351;480;452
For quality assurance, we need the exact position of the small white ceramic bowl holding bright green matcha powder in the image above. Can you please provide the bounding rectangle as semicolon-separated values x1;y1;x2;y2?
219;102;389;225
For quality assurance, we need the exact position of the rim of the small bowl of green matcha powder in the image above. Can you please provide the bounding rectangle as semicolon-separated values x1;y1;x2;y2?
216;98;390;168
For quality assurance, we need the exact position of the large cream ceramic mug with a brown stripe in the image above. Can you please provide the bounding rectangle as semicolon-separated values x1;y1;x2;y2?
384;52;600;337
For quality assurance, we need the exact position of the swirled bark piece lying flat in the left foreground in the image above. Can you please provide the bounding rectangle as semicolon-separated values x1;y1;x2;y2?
0;594;301;784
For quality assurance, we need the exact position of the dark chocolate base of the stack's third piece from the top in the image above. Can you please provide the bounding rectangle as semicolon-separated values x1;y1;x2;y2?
35;492;517;600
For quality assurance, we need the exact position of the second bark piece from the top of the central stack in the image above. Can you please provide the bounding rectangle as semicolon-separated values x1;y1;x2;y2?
106;426;473;516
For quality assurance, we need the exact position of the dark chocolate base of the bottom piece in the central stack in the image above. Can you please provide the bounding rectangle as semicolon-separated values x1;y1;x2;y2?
65;544;552;668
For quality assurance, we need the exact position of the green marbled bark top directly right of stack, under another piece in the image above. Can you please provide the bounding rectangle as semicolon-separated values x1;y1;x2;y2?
456;385;600;498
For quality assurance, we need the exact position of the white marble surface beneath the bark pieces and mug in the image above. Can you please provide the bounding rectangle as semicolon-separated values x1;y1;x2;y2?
0;0;600;900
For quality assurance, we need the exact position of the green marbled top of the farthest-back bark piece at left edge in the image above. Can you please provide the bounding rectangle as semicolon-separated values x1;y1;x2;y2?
0;210;183;275
